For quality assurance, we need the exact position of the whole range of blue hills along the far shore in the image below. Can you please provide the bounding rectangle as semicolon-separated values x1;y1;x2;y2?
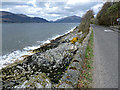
0;11;81;23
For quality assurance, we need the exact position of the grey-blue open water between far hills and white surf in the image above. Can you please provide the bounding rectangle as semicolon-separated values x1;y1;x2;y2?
2;23;79;55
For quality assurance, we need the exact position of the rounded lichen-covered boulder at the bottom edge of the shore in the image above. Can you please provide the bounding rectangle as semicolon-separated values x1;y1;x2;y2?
14;73;52;88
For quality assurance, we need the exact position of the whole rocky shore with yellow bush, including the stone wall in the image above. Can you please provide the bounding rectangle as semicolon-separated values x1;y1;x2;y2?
0;27;91;88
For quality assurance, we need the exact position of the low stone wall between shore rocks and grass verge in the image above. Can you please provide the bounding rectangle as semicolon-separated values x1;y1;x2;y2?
57;29;91;88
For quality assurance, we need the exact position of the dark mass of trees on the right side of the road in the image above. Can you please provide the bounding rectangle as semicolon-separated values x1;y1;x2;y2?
95;2;120;26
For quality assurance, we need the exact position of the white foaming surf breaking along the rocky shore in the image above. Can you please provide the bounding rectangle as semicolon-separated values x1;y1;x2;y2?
0;26;78;69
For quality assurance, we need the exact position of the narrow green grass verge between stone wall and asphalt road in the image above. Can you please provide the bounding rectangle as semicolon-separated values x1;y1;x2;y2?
78;30;94;88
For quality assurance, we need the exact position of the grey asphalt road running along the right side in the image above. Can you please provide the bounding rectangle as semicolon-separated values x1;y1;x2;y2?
91;25;118;88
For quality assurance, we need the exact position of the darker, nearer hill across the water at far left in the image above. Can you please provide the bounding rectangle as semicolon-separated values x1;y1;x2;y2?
0;11;48;23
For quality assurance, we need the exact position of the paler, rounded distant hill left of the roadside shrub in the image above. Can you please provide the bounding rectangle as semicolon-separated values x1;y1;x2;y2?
54;16;81;23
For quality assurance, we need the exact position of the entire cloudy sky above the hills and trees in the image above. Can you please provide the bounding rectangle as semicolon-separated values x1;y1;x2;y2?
0;0;104;21
